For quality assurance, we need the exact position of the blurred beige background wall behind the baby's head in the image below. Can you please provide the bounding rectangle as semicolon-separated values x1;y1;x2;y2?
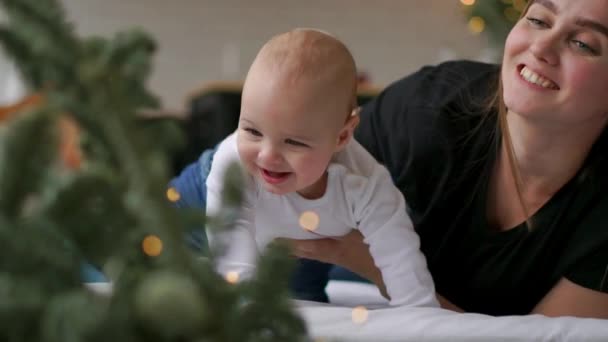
0;0;496;113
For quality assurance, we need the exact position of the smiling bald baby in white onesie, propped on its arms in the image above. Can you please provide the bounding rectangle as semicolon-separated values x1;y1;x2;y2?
207;29;438;306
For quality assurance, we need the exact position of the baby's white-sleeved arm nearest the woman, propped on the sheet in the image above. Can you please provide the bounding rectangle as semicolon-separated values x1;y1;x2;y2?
355;165;439;307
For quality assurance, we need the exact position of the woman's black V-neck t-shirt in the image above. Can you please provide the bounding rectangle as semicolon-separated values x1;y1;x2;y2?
355;61;608;315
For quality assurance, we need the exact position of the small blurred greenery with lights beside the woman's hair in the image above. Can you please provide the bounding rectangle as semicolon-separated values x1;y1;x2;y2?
460;0;527;49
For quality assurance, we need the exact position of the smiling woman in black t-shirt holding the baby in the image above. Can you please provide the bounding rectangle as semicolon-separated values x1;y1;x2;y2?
171;0;608;318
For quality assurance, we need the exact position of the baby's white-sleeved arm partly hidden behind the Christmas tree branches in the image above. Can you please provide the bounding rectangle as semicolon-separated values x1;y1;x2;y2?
207;134;258;279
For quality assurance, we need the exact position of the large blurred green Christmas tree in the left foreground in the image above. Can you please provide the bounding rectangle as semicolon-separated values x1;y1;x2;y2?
0;0;306;342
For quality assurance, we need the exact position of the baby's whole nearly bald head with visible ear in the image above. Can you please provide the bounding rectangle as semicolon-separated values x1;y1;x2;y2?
237;29;359;180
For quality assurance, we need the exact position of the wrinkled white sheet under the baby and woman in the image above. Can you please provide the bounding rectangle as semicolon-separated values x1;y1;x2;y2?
296;281;608;342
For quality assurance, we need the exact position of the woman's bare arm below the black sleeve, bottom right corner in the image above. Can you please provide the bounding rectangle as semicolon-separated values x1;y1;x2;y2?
532;278;608;319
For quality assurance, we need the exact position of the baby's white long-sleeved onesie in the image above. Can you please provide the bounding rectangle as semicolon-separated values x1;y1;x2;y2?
207;133;439;306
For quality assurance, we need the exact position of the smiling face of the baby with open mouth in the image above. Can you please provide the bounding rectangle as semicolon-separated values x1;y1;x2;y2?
237;74;346;198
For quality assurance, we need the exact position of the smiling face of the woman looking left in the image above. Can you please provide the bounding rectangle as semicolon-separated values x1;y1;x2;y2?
502;0;608;127
